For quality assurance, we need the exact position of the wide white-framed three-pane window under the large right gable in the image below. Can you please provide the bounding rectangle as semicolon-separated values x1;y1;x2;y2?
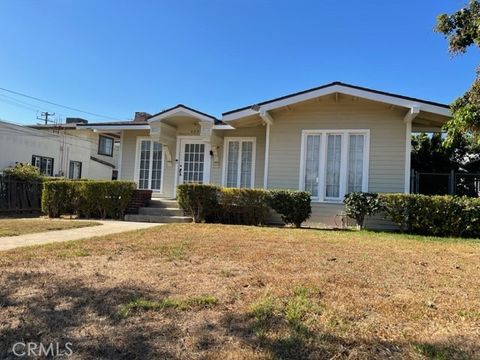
299;130;370;202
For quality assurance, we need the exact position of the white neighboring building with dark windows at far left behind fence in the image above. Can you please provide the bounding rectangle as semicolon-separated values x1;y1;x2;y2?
0;121;118;179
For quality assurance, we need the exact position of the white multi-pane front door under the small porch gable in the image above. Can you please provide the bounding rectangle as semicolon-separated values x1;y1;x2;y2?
178;139;210;184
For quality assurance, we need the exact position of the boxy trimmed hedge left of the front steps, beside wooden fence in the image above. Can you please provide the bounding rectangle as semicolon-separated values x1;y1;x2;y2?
42;180;136;219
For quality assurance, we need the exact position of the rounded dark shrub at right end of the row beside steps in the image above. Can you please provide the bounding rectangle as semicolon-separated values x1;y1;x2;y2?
269;190;312;228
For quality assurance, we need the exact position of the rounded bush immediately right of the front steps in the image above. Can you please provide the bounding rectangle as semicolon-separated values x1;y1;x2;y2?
177;184;220;223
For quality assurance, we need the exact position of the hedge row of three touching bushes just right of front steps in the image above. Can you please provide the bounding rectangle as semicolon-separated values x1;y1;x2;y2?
177;184;312;227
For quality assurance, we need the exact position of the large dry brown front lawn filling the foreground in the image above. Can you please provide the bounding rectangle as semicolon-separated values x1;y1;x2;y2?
0;224;480;359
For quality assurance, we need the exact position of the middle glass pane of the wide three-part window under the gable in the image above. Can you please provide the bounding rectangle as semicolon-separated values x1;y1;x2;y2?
325;135;342;198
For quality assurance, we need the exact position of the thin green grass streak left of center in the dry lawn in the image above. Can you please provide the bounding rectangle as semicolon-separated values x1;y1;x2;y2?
118;295;218;318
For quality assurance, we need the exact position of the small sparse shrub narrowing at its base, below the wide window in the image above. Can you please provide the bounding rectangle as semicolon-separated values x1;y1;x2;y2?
343;192;382;229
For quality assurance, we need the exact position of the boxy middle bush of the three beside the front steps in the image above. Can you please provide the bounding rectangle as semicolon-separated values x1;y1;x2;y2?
216;188;270;225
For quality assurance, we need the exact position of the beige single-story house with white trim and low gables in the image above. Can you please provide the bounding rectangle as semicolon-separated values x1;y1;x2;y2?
77;82;450;225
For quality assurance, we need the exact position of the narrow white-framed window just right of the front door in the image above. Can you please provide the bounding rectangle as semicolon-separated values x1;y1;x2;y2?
222;137;256;188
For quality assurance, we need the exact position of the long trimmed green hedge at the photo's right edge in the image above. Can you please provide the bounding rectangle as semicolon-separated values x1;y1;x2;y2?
380;194;480;238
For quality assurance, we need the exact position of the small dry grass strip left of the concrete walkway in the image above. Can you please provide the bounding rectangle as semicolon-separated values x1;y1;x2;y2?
0;218;100;237
